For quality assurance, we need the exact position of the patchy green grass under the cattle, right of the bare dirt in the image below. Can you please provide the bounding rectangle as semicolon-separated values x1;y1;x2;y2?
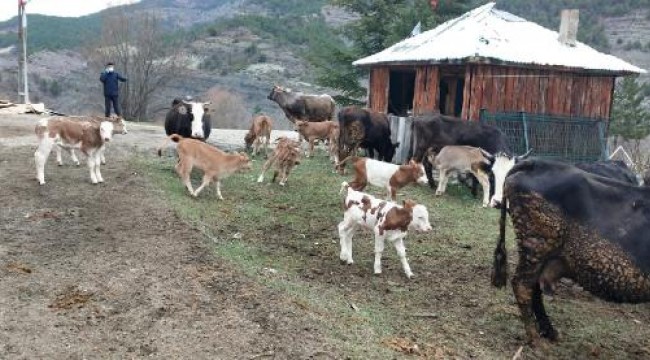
134;149;650;359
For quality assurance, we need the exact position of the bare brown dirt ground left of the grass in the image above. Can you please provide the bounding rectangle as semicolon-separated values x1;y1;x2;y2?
0;116;334;359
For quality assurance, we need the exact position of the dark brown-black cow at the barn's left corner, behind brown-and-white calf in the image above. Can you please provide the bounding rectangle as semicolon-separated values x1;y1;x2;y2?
338;106;399;173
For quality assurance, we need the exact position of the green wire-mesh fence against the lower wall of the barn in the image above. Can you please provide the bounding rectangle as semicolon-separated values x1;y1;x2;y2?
480;110;608;163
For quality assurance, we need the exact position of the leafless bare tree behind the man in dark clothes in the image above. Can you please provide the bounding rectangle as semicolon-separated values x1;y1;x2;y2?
91;8;188;120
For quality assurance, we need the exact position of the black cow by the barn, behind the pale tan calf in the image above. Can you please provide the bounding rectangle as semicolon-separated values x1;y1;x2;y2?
412;114;510;188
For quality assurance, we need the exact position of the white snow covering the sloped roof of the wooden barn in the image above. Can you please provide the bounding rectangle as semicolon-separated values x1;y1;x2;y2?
353;2;646;74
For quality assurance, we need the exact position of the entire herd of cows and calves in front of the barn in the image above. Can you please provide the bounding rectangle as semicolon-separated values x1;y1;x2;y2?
30;86;650;343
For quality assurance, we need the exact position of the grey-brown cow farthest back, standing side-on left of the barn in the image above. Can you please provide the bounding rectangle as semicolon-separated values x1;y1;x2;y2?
268;85;336;123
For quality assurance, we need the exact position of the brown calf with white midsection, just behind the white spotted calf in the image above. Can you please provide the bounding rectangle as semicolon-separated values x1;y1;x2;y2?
337;156;428;201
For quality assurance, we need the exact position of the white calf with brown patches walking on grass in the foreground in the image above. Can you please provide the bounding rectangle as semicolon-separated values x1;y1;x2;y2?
338;182;432;279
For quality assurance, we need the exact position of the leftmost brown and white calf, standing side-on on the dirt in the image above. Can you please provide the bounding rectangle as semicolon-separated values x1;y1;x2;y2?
34;117;114;185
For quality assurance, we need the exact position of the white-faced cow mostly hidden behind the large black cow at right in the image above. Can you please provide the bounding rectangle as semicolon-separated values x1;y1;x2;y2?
490;157;638;207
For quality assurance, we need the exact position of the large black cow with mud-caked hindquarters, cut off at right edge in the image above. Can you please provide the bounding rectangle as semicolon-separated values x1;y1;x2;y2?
492;159;650;345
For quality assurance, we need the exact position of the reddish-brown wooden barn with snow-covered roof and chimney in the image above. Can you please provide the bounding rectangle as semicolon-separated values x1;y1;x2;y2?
354;3;645;120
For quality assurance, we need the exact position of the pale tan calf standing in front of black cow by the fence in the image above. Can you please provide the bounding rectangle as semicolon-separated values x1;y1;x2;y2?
427;145;494;207
